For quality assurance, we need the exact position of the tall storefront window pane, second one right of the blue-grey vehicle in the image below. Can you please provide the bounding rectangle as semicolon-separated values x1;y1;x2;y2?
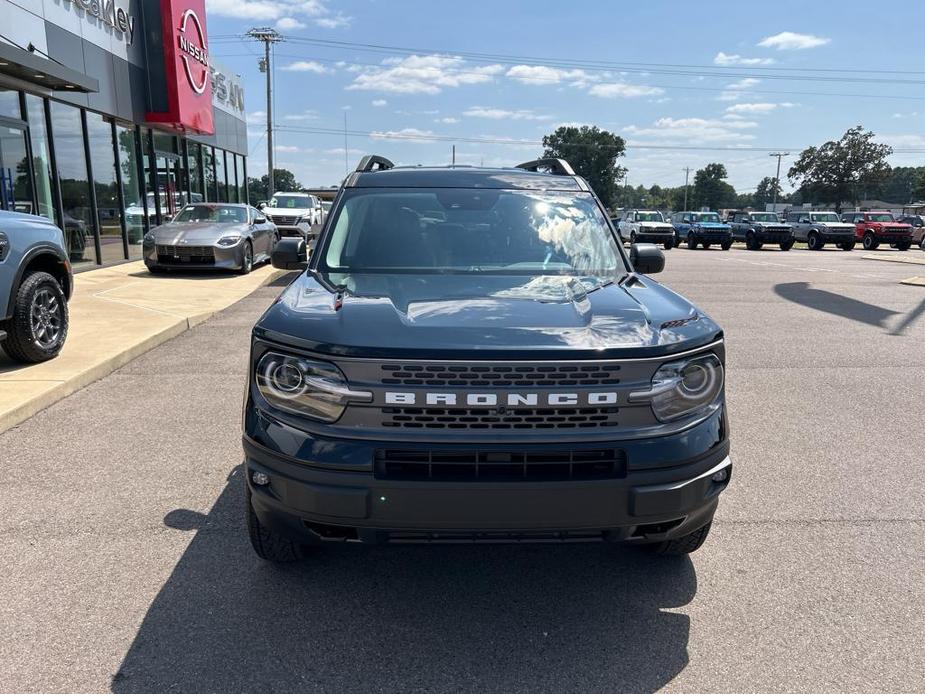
87;112;125;264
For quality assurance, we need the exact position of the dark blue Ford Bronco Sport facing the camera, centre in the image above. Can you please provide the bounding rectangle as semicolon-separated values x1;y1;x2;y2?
243;156;732;561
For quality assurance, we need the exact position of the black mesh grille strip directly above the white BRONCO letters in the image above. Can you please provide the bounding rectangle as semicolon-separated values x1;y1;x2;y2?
382;364;620;388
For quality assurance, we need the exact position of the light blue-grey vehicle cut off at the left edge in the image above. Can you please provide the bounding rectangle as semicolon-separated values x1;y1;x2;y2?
0;211;73;364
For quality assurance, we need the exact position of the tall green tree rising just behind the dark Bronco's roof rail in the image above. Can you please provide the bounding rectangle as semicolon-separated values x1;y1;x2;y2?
543;125;626;208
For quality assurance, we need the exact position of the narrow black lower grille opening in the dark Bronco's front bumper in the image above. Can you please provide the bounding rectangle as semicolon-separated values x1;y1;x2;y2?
375;448;626;482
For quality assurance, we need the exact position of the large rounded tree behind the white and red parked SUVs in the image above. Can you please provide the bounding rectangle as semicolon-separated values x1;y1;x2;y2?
787;125;893;212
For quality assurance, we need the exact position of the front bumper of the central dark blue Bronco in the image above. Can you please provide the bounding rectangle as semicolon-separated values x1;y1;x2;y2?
243;404;732;544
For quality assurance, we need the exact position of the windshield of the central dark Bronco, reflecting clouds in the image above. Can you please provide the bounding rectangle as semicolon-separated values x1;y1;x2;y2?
322;188;626;277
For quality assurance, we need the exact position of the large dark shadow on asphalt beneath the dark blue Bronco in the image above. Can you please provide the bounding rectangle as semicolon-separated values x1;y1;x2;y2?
112;468;697;694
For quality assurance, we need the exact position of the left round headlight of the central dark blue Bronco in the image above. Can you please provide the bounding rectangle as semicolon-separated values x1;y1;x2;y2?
257;352;373;422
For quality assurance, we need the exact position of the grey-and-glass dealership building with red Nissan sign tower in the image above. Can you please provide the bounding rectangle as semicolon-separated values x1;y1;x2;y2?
0;0;247;270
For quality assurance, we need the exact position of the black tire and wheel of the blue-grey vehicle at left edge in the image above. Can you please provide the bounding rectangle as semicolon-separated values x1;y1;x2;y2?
3;272;68;364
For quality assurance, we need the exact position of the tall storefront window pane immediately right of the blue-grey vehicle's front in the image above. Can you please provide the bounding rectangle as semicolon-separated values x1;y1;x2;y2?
51;101;96;265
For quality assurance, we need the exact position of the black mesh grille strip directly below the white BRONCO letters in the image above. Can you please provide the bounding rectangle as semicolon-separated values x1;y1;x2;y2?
382;406;619;429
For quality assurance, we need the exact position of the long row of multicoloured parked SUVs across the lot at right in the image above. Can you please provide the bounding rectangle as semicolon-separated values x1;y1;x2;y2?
611;210;925;251
